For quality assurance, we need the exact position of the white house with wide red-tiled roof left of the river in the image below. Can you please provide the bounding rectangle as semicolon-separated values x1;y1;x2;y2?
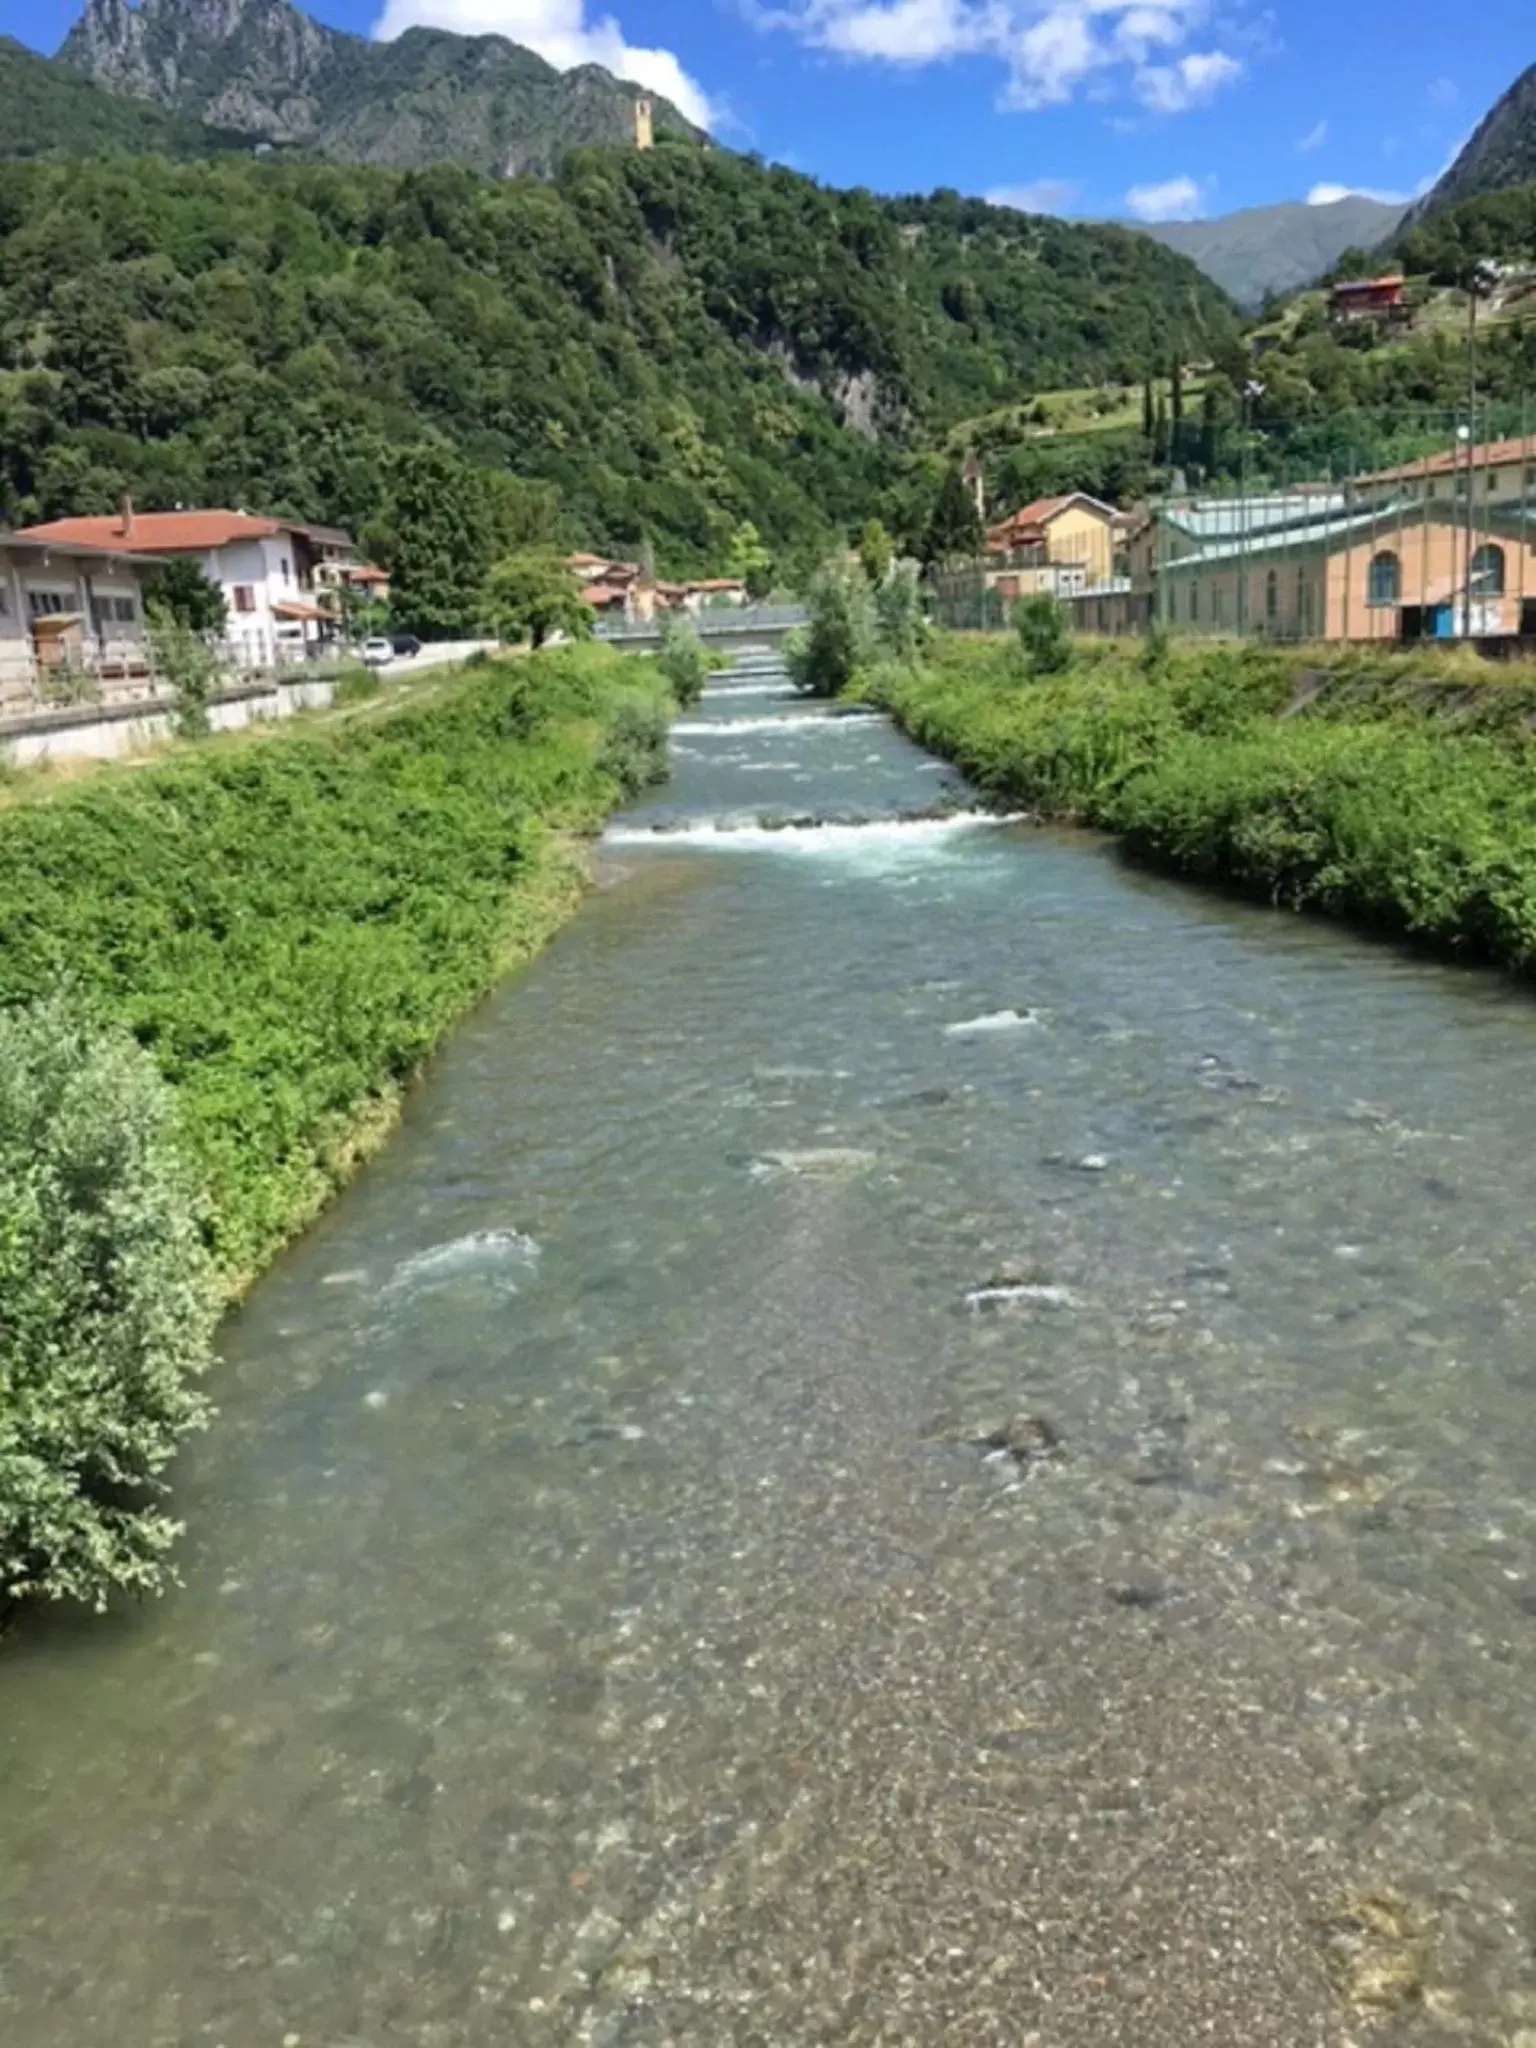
20;498;356;670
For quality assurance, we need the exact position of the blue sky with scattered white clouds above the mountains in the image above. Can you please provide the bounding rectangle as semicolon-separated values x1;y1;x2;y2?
0;0;1536;219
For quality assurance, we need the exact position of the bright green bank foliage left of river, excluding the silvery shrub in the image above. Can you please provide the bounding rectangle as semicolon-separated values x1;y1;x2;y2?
0;647;670;1282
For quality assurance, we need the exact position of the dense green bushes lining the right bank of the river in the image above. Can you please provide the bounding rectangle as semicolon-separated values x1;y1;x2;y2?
866;639;1536;973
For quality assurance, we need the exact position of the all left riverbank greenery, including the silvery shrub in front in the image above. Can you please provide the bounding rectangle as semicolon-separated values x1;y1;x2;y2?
0;647;670;1602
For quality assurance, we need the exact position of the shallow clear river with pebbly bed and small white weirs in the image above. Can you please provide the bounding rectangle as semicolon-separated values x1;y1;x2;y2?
0;655;1536;2048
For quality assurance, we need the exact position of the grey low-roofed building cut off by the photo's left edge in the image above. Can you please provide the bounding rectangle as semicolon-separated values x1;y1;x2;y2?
0;532;154;717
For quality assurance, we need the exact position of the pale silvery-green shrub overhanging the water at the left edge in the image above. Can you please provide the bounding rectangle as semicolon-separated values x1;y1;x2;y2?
0;995;219;1608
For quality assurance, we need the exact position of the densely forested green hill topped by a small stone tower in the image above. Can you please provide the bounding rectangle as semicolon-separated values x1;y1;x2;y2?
0;143;1237;569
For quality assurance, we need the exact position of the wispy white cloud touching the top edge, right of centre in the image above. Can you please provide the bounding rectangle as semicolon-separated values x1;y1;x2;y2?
753;0;1243;115
